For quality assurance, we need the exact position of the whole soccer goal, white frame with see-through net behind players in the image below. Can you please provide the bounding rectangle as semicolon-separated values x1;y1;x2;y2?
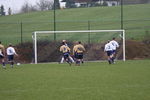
32;30;125;64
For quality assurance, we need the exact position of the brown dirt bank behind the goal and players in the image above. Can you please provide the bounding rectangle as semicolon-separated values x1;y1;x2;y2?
15;40;150;63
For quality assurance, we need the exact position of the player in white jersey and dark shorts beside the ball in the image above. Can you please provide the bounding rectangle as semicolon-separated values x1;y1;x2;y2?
6;43;18;68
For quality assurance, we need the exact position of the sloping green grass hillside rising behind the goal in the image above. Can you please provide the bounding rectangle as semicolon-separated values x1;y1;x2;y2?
0;4;150;44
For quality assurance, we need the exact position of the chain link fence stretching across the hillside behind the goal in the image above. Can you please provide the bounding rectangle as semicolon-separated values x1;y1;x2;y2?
0;19;150;44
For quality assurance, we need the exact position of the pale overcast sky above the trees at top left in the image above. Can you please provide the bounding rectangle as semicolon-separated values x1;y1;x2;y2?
0;0;42;14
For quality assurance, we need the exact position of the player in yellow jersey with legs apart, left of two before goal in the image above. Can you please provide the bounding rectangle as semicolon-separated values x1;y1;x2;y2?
60;42;72;65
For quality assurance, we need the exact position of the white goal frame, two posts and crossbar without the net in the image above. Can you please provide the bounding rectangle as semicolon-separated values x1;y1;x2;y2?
32;29;126;64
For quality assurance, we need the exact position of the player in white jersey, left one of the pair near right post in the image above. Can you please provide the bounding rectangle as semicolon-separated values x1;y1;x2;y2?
104;40;113;64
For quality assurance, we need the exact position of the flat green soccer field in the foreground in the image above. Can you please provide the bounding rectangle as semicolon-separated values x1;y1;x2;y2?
0;60;150;100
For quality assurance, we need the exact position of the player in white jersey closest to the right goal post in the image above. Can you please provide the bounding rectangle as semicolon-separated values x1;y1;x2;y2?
110;37;119;62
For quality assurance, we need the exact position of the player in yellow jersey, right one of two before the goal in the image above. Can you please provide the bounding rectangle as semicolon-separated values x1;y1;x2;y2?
73;41;85;66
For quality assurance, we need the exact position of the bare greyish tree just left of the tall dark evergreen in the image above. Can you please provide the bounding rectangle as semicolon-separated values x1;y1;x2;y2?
36;0;53;11
